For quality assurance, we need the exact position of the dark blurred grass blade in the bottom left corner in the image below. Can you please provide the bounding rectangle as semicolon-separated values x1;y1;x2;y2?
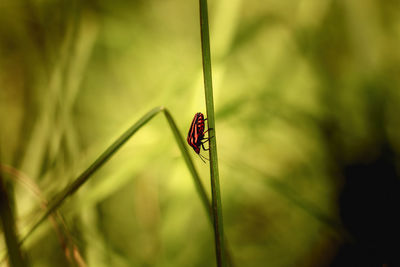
0;161;27;267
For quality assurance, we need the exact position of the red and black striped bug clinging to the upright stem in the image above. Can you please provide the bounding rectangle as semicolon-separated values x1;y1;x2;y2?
186;112;212;163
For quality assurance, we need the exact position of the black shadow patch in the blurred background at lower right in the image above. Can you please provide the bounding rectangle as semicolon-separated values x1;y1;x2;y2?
331;144;400;267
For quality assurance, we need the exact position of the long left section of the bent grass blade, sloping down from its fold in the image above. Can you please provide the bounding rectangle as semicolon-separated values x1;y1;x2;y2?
21;107;163;243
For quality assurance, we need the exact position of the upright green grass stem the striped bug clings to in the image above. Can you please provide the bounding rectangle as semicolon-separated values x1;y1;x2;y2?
199;0;226;267
